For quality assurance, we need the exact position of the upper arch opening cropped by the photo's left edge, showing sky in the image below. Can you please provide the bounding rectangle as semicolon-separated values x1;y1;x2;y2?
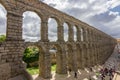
0;3;7;42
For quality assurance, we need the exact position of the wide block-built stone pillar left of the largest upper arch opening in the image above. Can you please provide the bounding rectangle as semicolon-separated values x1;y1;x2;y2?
6;11;23;40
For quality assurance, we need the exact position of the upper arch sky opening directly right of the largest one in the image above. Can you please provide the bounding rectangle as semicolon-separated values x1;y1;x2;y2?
48;18;58;42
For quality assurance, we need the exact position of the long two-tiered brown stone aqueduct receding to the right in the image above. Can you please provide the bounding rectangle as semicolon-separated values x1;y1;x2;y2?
0;0;116;80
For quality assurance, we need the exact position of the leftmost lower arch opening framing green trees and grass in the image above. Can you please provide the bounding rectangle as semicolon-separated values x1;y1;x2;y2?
23;46;42;76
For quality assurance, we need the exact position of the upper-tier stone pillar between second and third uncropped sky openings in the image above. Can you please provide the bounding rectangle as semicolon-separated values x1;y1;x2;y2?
57;23;64;42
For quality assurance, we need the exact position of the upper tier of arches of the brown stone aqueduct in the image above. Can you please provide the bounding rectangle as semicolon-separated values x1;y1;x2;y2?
0;0;115;42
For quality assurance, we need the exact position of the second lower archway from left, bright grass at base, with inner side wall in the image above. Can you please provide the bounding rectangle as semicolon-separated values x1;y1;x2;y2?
50;45;63;74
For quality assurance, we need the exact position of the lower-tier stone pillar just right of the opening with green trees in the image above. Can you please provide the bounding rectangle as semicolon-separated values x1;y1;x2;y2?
39;44;52;79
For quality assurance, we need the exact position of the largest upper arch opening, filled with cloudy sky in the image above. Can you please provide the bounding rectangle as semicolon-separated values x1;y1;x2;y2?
22;11;41;42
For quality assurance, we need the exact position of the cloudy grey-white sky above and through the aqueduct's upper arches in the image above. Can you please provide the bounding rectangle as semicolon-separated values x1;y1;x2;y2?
0;0;120;41
